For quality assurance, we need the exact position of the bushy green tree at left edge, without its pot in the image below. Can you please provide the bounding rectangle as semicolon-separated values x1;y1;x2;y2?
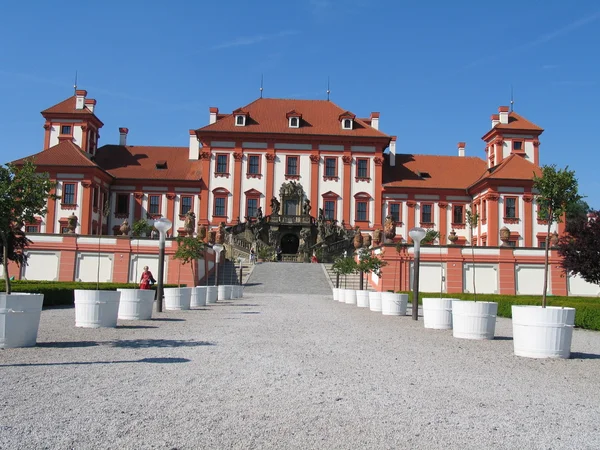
0;160;57;294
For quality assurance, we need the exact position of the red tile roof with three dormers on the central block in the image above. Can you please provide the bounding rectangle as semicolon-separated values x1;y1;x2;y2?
198;98;389;137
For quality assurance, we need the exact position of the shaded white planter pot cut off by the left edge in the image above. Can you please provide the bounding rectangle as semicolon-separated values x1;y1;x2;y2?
0;293;44;348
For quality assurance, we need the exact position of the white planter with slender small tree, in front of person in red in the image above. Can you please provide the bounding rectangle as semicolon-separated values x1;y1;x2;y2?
117;219;156;320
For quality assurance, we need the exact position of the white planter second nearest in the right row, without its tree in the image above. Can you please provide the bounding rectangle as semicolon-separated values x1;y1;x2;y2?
452;300;498;339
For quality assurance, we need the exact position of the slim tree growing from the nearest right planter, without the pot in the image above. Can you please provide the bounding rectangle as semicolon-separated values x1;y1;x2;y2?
533;165;583;308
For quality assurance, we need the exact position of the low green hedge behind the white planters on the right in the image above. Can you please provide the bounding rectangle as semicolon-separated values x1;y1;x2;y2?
403;291;600;331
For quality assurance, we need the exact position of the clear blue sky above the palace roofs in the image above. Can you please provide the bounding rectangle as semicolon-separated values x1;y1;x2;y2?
0;0;600;208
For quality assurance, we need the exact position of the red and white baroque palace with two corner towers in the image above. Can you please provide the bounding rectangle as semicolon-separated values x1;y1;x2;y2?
15;90;561;253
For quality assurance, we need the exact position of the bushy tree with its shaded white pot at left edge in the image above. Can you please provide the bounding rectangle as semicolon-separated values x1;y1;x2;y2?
0;161;57;348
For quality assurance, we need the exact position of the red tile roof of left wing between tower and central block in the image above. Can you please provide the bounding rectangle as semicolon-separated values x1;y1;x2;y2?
95;145;202;181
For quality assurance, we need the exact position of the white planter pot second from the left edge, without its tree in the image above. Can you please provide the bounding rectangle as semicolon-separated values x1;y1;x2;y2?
75;289;121;328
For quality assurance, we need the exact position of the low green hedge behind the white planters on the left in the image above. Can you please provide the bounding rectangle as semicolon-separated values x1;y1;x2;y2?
0;280;180;306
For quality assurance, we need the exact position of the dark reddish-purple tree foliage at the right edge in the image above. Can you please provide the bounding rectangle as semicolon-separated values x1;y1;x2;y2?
558;211;600;284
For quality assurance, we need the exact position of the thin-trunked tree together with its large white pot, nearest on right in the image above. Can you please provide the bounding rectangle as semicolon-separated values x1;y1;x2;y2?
512;165;582;358
